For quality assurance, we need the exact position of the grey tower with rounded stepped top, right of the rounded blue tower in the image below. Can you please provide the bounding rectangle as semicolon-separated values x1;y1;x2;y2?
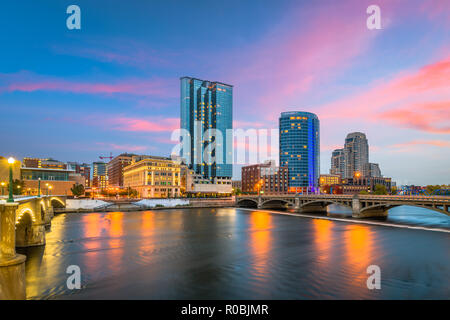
344;132;369;179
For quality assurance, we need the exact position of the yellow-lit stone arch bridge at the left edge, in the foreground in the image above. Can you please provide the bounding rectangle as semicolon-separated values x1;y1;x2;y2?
0;196;66;300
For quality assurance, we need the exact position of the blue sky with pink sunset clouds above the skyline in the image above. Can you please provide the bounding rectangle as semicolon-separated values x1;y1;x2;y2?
0;0;450;185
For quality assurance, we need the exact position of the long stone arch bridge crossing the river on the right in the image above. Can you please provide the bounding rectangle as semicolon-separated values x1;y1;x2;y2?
235;194;450;218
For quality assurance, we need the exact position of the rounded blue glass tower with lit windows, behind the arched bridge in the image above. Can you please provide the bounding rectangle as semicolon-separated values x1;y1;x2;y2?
279;111;320;192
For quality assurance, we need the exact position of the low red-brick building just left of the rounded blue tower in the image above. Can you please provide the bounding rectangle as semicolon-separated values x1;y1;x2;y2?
241;160;288;194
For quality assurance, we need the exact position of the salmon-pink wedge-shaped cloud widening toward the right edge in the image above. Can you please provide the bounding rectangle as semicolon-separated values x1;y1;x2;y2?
318;56;450;134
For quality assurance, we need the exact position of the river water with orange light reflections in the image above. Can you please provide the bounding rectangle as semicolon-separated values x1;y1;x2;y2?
16;207;450;299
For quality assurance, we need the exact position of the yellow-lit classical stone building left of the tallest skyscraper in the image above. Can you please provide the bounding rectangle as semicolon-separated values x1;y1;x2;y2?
123;156;182;198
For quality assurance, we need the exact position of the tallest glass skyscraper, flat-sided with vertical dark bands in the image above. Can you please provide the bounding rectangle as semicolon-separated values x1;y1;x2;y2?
180;77;233;181
